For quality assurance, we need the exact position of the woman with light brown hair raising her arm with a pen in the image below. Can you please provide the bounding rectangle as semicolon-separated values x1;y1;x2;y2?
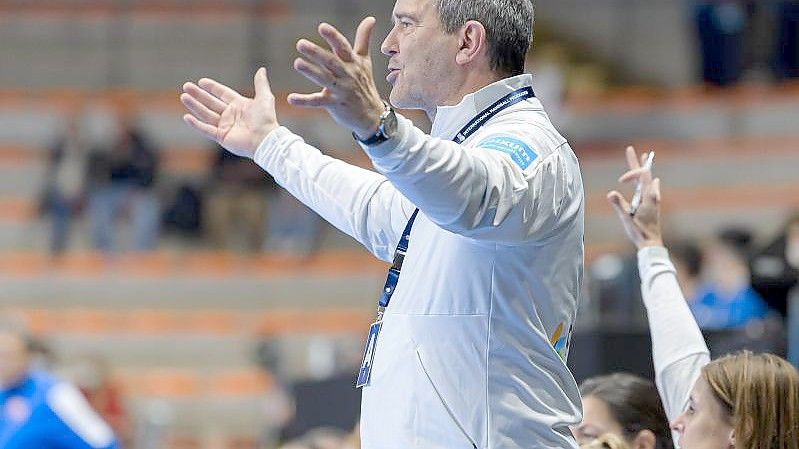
608;147;799;449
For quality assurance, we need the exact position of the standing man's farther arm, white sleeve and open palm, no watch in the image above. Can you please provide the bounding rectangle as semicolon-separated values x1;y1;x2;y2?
180;41;413;260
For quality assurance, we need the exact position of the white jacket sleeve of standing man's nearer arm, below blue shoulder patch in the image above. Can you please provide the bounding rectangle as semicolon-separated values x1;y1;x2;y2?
366;115;582;243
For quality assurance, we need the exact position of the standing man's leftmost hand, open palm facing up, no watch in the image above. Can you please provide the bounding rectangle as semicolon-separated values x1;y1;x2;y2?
180;68;279;158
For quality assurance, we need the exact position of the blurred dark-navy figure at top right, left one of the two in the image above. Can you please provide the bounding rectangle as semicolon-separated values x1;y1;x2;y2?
694;0;747;86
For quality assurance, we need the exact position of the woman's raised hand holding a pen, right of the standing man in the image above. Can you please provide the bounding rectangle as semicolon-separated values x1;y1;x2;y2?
608;147;663;249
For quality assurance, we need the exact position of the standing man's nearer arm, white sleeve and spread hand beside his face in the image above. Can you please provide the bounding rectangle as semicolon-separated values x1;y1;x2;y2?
288;18;582;243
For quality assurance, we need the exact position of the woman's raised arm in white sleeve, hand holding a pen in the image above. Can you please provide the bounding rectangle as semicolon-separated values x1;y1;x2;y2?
608;147;710;420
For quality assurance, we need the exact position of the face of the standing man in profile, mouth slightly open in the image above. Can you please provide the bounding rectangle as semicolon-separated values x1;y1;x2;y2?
381;0;458;112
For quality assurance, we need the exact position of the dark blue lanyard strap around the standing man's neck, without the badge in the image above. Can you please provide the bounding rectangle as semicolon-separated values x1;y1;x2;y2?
377;86;535;321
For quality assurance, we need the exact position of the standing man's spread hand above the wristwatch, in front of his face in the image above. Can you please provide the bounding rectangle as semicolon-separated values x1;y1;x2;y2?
288;17;385;137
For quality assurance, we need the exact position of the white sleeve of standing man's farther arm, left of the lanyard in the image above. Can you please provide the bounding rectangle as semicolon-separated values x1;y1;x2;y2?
253;127;414;262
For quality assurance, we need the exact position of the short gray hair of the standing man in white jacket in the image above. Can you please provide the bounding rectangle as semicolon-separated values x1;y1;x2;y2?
435;0;534;75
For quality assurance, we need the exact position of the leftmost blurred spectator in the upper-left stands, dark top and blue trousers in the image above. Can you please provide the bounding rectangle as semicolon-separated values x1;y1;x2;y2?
40;113;88;254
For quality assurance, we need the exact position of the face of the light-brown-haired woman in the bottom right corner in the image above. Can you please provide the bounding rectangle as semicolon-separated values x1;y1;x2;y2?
671;376;733;449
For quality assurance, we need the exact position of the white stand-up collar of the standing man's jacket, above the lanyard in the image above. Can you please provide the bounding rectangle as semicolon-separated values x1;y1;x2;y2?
430;74;542;139
